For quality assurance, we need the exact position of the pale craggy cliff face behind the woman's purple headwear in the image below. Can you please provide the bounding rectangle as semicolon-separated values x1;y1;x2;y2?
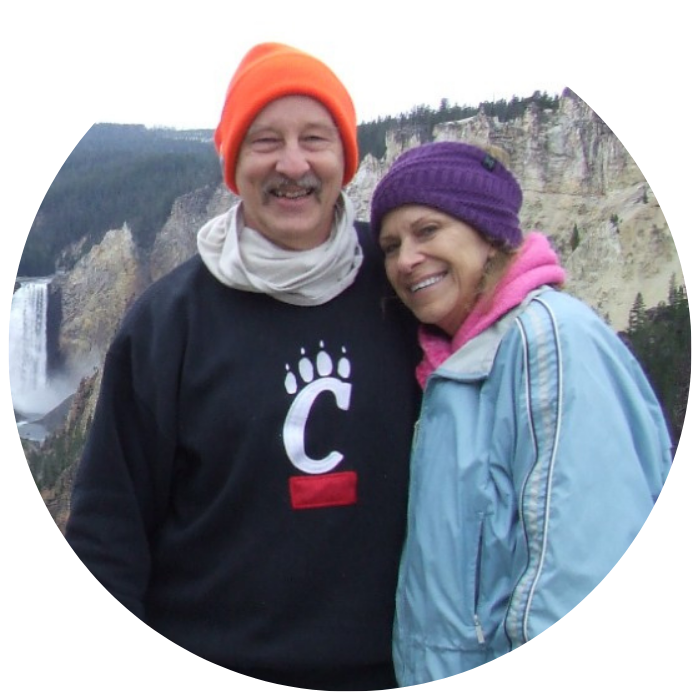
348;90;684;331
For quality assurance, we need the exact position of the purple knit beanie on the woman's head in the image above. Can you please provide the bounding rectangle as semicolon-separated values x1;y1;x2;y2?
370;141;523;249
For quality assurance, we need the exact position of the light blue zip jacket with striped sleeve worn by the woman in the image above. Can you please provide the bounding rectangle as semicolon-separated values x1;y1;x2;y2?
394;288;672;687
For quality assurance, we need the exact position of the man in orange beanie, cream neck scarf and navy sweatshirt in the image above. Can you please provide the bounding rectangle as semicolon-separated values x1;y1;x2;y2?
66;44;418;691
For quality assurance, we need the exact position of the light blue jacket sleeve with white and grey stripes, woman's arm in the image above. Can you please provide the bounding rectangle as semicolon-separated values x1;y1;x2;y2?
506;294;671;648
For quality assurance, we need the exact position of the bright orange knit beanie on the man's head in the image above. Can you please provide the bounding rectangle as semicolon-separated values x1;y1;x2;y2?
214;43;359;194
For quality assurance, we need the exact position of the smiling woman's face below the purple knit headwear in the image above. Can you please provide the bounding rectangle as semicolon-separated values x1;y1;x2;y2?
379;204;496;336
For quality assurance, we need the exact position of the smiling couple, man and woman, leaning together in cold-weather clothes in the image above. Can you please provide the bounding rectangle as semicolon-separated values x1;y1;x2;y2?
66;44;671;691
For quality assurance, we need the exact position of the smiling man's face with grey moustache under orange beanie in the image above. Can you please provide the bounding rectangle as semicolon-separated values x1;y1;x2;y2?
236;95;345;250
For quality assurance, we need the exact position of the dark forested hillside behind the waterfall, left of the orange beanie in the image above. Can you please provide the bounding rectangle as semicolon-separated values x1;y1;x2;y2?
17;124;221;276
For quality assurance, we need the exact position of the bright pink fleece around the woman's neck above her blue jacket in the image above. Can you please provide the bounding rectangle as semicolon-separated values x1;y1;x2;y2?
416;233;566;388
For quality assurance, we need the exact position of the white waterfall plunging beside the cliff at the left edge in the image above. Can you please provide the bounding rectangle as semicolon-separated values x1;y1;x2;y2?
8;279;51;417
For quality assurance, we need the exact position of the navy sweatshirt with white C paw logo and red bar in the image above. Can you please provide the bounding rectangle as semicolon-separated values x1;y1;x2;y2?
66;225;419;691
